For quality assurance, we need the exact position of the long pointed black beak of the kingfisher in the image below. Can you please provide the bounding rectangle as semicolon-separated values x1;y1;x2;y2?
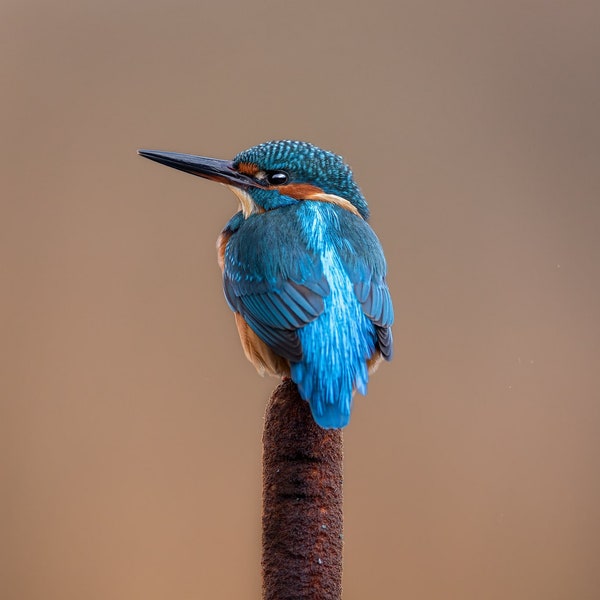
138;150;259;189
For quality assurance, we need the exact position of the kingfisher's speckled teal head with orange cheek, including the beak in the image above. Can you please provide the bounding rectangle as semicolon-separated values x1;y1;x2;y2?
139;140;369;220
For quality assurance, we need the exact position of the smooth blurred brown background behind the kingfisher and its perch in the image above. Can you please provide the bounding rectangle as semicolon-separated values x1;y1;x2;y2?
0;0;600;600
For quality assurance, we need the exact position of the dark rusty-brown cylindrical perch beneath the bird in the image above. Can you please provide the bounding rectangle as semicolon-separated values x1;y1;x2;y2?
262;379;343;600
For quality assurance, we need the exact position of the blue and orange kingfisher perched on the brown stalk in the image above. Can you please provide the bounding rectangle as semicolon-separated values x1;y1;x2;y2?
138;140;394;429
